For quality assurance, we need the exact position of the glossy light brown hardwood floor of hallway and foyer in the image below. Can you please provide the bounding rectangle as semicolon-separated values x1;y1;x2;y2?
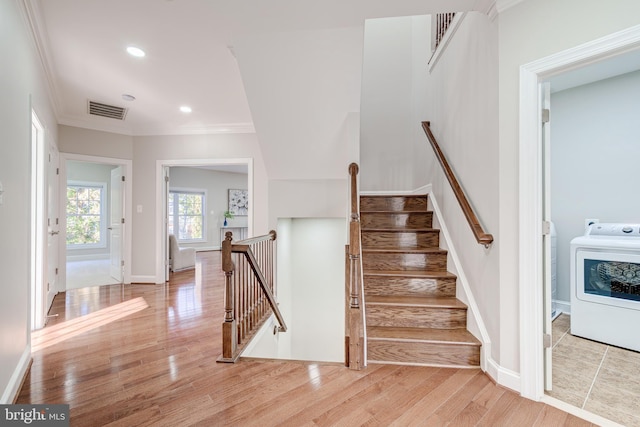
17;252;592;427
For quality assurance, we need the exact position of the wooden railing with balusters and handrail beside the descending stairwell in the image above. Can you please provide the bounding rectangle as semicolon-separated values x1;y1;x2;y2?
218;230;287;363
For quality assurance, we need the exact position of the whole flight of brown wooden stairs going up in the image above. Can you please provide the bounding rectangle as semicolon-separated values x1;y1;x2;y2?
360;196;480;367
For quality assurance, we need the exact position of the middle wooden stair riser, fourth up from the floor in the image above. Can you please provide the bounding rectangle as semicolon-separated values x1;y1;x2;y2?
362;251;447;271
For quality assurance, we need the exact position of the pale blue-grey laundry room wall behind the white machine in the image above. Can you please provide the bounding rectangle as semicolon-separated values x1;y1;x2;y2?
551;71;640;302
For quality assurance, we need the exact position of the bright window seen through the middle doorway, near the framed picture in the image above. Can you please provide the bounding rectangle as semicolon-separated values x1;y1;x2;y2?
168;190;205;241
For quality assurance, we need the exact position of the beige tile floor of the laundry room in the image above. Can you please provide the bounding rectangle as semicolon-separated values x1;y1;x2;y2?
547;314;640;427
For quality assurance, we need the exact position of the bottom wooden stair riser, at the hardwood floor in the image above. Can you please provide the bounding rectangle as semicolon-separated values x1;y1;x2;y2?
367;339;480;367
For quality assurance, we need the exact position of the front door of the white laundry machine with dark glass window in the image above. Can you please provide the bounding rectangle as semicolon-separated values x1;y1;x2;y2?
576;250;640;310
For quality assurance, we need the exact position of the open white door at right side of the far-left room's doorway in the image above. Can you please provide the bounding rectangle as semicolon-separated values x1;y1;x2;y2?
109;166;125;283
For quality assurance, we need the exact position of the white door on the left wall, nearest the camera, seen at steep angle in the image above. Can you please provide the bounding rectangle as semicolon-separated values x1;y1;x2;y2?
44;144;60;313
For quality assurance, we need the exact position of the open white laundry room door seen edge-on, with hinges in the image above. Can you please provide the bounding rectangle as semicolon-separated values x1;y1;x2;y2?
540;82;553;390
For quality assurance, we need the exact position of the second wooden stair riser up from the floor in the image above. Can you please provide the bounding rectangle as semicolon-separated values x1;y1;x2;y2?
366;304;467;329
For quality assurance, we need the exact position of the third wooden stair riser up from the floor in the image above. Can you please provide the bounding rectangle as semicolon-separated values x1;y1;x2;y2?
364;275;456;297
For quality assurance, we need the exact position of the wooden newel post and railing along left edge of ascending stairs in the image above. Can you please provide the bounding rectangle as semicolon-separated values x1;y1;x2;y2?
345;163;366;370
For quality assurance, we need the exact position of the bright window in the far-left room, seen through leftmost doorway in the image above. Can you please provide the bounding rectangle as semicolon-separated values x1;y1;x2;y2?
67;182;107;249
